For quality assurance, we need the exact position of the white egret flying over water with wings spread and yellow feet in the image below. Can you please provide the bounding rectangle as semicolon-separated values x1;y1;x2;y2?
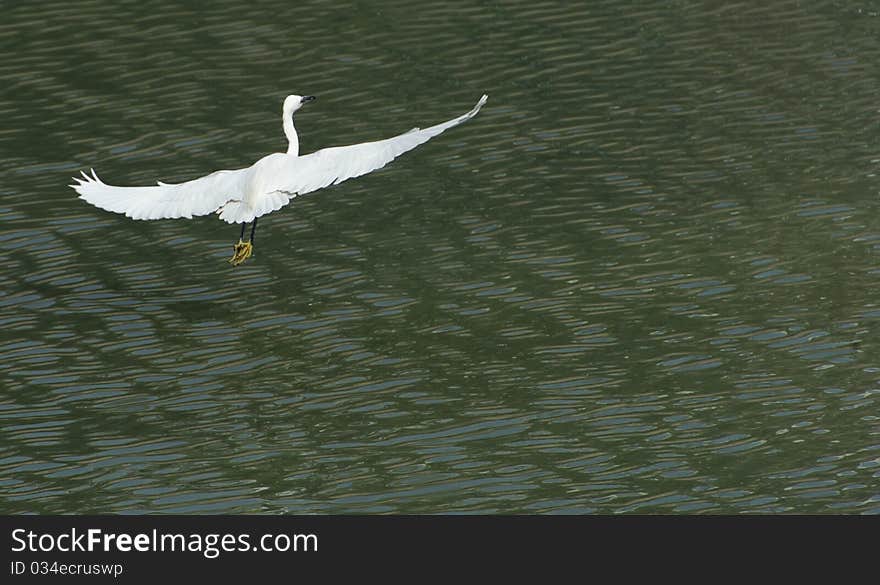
70;95;487;266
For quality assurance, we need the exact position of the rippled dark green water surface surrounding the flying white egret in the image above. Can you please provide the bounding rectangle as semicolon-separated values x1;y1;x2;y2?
0;0;880;513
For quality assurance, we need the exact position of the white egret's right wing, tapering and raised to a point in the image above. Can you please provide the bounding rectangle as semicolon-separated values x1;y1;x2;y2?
269;95;487;197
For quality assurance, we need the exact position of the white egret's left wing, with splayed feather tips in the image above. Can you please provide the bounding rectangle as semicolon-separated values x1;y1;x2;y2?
70;169;248;219
